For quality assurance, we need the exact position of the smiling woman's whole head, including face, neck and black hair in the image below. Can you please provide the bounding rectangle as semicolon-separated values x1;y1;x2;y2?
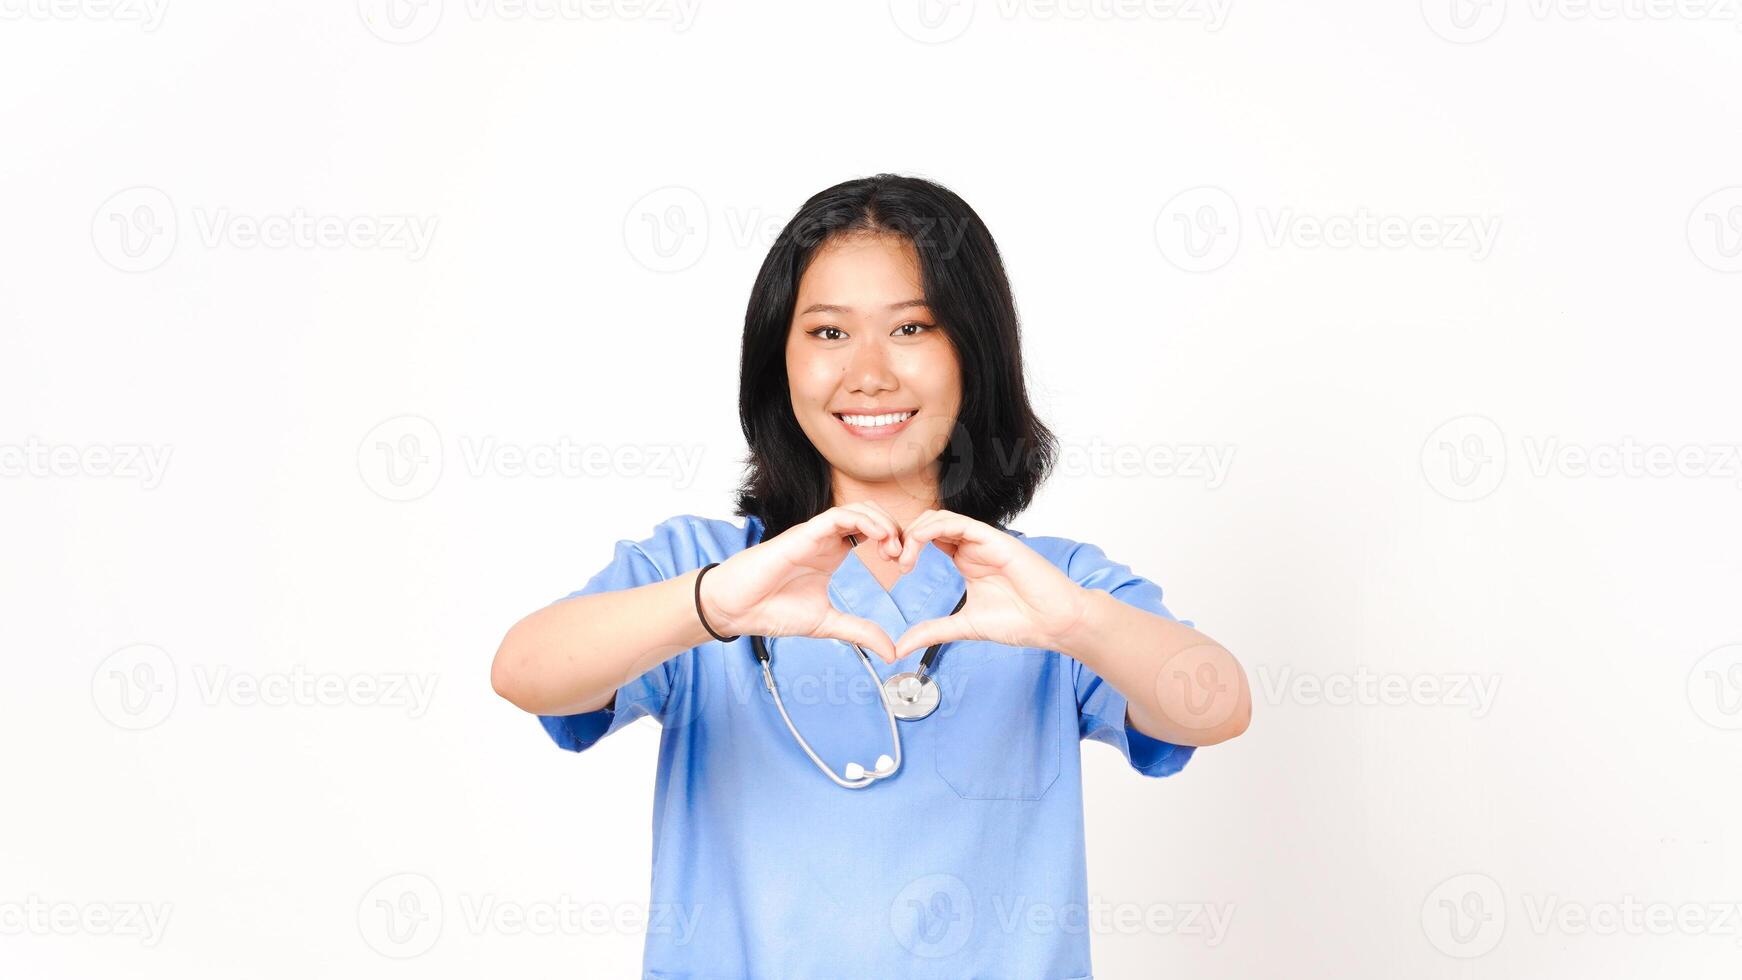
739;174;1056;543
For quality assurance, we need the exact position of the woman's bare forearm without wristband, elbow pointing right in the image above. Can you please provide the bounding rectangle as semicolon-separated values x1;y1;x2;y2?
1056;588;1252;745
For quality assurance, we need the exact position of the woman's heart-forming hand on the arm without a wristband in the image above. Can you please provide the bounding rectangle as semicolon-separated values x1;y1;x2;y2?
895;510;1089;660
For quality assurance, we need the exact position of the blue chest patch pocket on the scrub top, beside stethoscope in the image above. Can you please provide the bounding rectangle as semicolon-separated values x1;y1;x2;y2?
940;644;1066;799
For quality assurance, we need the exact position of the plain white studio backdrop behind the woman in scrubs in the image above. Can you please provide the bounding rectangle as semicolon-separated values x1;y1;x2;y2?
0;0;1742;980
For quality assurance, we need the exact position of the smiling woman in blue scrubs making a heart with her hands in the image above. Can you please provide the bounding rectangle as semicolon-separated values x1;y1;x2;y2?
491;174;1251;980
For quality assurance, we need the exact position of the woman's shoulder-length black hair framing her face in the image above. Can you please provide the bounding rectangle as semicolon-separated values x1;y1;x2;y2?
737;174;1057;540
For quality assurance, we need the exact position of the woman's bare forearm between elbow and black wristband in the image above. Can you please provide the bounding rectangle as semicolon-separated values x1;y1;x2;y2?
490;571;712;715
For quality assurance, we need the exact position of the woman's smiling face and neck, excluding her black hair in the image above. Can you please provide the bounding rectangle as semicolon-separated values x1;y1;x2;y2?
786;233;962;507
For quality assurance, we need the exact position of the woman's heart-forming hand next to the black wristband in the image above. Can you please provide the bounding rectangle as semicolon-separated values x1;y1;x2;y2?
702;501;902;663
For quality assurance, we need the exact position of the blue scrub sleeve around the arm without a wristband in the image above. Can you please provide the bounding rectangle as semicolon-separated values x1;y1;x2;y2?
1066;545;1197;776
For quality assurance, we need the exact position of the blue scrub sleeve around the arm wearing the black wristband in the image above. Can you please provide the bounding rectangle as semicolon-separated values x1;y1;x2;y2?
538;526;693;752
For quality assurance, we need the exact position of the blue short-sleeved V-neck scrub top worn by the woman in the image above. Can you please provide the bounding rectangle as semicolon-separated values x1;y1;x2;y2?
540;513;1193;980
